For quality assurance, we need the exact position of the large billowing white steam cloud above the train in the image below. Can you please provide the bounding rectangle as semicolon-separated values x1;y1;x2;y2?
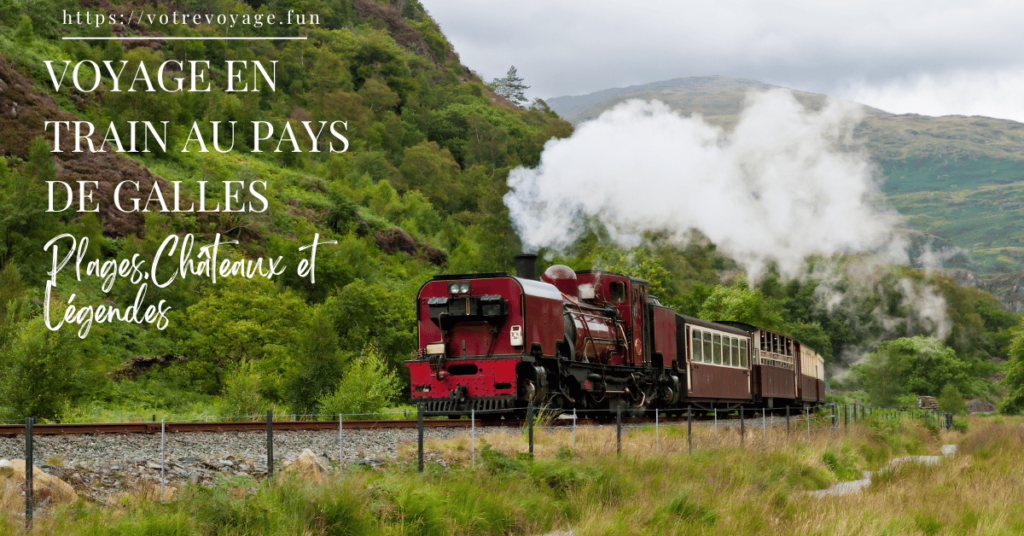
505;90;907;281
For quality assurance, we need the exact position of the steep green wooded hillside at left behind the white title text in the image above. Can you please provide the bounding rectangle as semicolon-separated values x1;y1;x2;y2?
0;0;571;420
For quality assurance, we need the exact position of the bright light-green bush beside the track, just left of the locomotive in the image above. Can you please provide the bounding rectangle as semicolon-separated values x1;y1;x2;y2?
319;344;401;419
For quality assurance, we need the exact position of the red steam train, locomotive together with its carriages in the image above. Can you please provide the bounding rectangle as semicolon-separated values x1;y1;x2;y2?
406;255;825;416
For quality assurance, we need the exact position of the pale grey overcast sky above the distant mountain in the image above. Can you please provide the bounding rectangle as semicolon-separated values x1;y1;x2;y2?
421;0;1024;121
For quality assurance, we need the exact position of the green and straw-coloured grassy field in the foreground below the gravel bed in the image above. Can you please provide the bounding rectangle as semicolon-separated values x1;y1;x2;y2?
0;417;1024;536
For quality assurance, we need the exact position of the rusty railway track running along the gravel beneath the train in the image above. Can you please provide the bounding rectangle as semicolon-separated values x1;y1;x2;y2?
0;416;770;438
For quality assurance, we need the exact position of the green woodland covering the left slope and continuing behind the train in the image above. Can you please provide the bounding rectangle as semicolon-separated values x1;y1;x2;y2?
0;0;1024;421
